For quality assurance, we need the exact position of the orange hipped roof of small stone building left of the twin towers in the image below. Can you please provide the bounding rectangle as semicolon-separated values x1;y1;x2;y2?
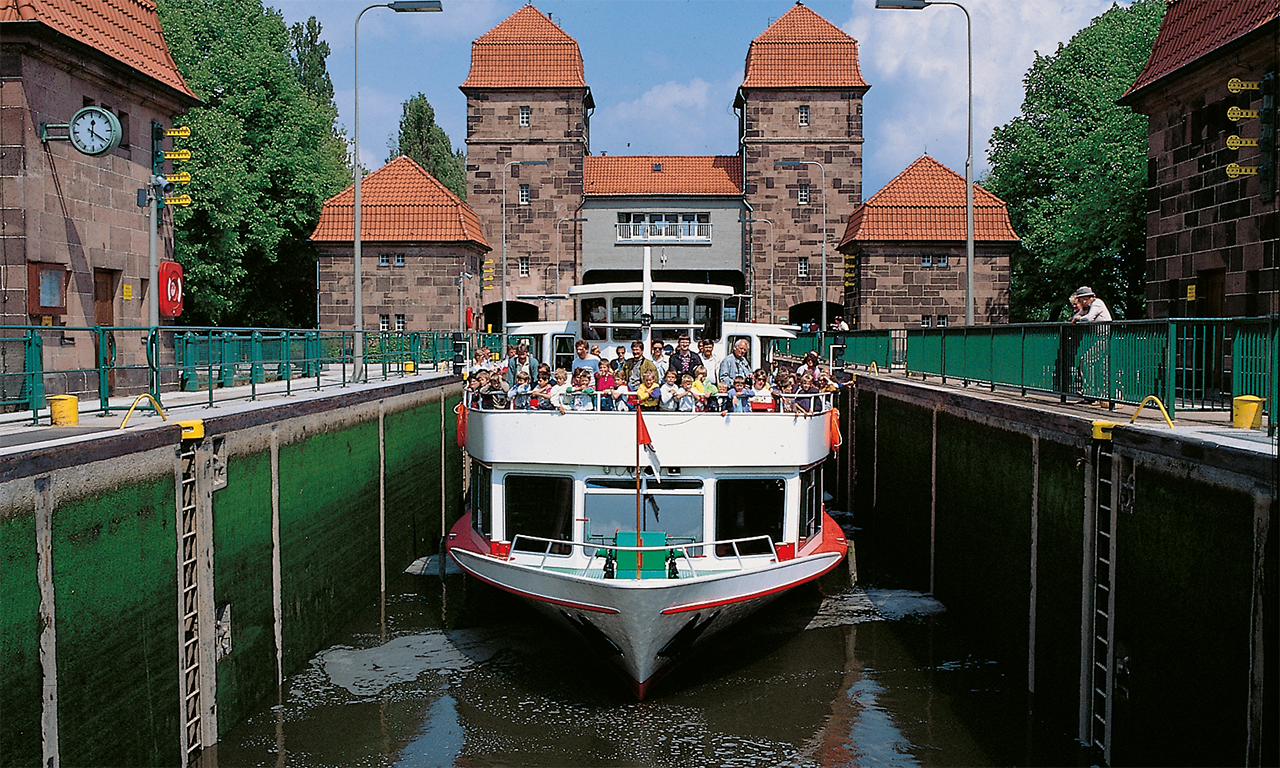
311;155;489;250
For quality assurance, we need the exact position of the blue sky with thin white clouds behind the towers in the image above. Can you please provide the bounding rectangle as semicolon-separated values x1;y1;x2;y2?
266;0;1131;198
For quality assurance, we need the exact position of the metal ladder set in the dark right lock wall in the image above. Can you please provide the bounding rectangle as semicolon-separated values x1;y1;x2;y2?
1088;442;1116;764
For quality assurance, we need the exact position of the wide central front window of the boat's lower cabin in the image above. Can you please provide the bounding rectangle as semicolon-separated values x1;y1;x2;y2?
582;479;703;541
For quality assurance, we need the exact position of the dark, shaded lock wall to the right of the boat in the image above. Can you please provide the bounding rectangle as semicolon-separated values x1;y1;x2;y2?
849;378;1277;767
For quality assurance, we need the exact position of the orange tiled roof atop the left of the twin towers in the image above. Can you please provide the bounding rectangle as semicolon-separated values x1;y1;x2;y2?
461;5;586;88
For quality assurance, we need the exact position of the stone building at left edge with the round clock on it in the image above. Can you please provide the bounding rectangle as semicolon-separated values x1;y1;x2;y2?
0;0;198;393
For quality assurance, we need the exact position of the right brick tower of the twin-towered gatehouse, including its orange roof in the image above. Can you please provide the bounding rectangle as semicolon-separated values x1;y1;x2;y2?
733;3;870;323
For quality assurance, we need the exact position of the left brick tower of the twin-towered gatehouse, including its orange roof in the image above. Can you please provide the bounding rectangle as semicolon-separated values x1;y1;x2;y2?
461;5;595;329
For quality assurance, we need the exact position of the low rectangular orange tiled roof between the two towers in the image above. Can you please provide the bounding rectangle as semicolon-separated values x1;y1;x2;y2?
582;155;742;197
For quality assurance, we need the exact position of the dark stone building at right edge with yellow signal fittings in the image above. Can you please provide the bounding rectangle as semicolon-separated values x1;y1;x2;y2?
1120;0;1280;317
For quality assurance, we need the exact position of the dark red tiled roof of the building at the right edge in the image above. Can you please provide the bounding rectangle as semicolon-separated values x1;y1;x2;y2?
1121;0;1280;99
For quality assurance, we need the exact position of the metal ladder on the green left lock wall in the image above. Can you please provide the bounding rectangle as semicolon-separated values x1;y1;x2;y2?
178;440;204;765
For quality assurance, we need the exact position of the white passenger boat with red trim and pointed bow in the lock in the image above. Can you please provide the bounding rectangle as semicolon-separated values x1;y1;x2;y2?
447;248;847;699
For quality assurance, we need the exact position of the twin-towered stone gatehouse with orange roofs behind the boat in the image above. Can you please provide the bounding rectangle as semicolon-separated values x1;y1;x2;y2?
461;3;869;325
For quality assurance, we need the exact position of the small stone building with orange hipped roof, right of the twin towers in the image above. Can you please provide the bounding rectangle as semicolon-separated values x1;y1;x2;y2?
840;155;1018;329
